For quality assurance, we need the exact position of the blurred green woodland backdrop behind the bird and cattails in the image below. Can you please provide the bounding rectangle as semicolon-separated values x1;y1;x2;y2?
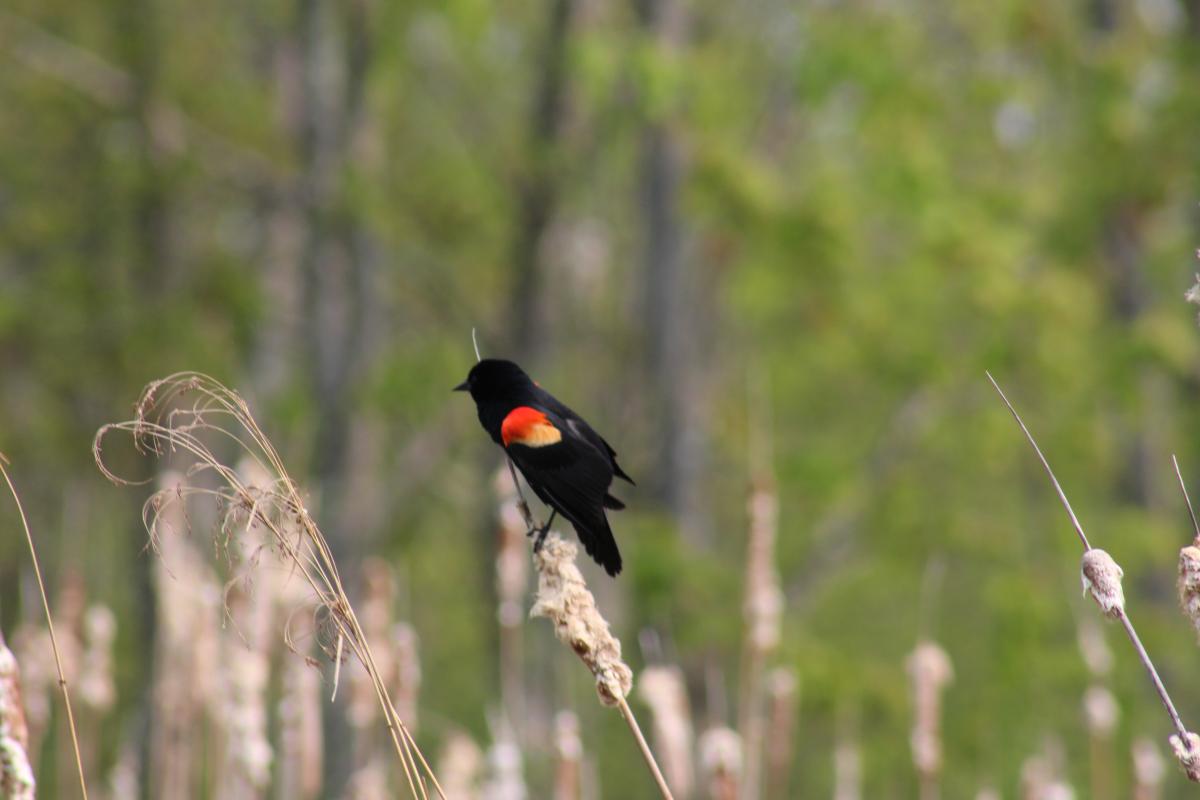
0;0;1200;800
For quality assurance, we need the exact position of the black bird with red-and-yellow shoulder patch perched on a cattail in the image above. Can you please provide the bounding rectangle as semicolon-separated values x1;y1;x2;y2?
455;359;634;576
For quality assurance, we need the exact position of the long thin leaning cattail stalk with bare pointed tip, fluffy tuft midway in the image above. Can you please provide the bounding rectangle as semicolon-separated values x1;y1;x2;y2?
988;373;1200;783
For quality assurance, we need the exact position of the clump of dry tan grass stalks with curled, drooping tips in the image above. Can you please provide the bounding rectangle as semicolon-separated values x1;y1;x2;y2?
92;372;445;798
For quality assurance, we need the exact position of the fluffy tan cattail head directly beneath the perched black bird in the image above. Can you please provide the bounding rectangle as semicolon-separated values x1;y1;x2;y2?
529;535;634;705
